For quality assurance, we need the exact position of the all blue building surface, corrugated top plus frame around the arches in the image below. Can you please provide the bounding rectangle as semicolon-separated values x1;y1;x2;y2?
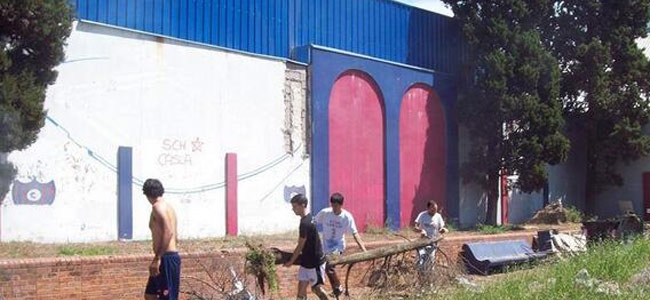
70;0;464;228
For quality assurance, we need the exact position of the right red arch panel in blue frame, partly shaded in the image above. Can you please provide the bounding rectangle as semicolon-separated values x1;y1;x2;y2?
399;84;446;227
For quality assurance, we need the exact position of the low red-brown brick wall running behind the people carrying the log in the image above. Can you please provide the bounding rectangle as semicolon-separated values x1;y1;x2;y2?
0;232;535;299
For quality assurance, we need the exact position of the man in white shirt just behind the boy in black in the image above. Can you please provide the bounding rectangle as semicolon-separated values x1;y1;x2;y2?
316;193;366;297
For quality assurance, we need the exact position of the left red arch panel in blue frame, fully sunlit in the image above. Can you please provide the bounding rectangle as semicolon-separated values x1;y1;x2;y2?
328;71;385;230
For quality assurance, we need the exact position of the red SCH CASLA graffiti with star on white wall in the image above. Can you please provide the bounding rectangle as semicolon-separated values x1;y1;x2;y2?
157;137;204;167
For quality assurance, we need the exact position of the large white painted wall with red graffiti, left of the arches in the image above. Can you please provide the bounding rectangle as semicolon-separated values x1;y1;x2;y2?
0;23;309;242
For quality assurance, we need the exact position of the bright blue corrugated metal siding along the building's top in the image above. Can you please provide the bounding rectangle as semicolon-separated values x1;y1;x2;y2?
70;0;463;73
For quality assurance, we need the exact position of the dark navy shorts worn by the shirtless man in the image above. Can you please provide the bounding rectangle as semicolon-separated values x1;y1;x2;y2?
144;252;181;300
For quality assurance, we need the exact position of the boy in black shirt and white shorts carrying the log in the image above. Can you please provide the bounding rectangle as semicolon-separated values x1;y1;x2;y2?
284;194;327;300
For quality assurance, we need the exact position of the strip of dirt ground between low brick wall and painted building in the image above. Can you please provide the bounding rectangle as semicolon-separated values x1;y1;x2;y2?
0;224;580;260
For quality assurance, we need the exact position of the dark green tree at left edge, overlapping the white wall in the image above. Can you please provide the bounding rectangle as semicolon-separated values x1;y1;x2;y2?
0;0;72;199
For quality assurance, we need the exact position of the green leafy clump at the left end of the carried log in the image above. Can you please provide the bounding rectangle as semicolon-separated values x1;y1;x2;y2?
240;241;279;291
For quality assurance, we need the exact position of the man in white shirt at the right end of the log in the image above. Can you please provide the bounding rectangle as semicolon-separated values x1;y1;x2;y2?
414;200;447;266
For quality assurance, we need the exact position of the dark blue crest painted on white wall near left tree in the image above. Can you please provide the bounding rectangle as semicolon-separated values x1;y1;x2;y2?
11;179;56;205
